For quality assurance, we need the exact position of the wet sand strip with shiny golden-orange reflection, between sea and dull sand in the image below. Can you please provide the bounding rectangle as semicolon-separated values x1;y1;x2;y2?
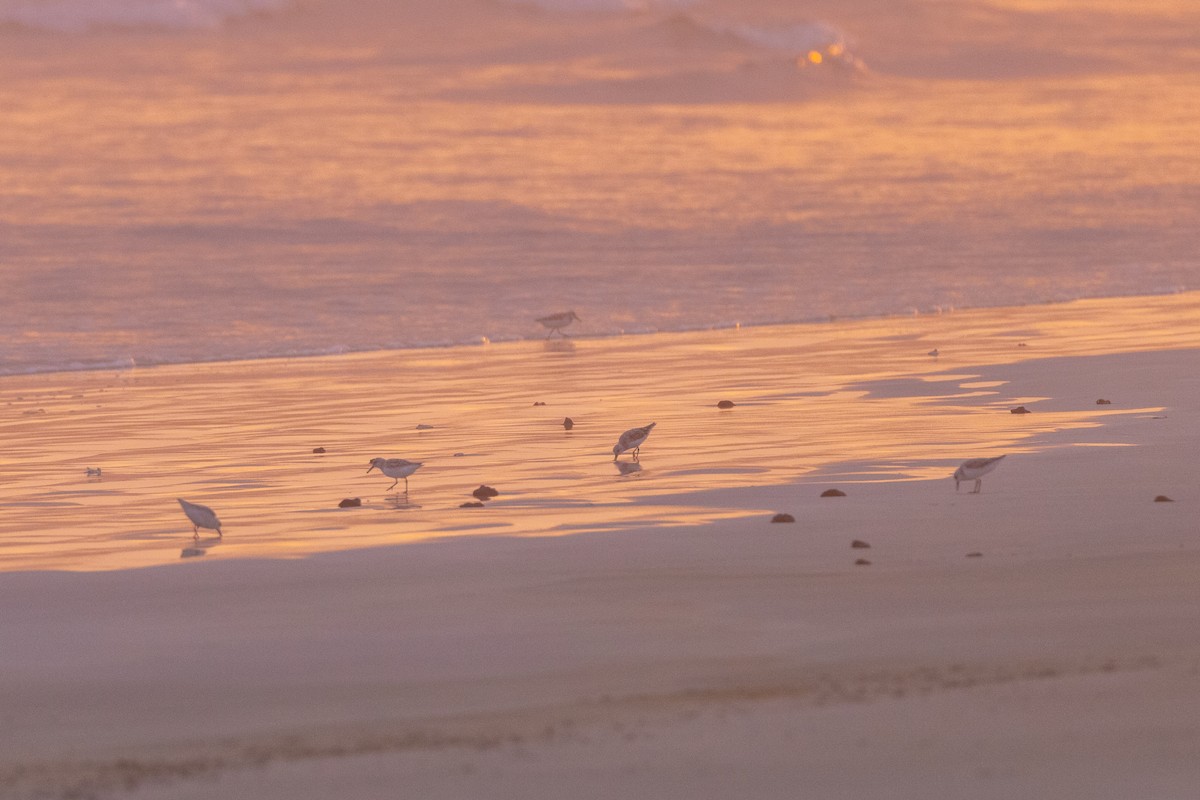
0;294;1200;570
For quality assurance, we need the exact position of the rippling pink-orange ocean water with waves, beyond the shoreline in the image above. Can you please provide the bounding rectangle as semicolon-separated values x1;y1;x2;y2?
0;0;1200;374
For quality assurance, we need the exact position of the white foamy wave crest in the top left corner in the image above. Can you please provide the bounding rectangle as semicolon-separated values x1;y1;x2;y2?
0;0;290;32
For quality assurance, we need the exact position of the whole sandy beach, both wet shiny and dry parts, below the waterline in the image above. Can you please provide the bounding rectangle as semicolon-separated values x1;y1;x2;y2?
0;293;1200;800
